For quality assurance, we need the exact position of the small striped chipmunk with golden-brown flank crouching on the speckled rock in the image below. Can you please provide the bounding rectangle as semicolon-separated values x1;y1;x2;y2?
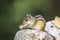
19;14;45;31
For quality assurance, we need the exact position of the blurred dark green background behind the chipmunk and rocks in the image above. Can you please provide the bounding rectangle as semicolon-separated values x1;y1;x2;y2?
0;0;60;40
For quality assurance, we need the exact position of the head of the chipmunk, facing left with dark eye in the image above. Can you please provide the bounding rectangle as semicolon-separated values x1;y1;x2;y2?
19;14;35;29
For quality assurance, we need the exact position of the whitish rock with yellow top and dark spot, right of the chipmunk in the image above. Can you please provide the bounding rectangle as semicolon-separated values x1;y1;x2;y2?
45;16;60;40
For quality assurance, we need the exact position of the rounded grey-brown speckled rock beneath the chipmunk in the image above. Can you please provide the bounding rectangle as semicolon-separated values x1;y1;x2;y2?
14;29;54;40
